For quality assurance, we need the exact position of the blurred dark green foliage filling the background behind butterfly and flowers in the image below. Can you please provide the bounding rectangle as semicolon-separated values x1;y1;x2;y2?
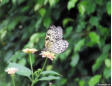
0;0;111;86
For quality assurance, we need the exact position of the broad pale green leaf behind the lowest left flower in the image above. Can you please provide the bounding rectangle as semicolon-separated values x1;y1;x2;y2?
8;63;32;77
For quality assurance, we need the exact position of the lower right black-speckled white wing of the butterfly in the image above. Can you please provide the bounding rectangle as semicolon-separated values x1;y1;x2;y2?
48;40;69;54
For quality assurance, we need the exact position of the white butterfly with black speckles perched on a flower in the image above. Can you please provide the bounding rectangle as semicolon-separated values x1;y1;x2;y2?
44;25;69;54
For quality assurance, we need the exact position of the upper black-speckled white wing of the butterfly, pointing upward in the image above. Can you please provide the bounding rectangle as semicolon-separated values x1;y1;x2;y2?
45;25;63;48
